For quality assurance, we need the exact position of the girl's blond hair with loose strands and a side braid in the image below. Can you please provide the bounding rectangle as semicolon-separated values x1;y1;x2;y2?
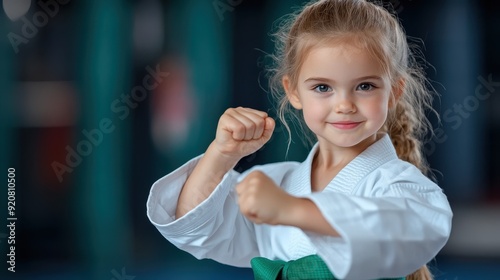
270;0;435;280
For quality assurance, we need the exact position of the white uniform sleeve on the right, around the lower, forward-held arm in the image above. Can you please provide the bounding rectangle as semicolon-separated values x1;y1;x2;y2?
306;184;452;279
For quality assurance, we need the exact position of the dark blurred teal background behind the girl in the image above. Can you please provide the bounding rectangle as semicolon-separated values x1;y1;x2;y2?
0;0;500;280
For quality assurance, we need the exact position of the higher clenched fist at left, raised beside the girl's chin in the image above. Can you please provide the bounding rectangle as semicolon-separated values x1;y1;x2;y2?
213;107;275;160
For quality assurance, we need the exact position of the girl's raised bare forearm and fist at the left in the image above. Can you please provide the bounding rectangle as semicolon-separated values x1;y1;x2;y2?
176;107;275;219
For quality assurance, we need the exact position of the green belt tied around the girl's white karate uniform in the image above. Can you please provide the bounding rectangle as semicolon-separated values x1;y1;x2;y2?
250;255;405;280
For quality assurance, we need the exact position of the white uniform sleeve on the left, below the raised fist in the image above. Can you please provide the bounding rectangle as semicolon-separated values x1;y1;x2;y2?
147;156;259;267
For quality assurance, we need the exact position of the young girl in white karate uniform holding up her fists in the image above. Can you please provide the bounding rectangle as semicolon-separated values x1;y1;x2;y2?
147;0;452;279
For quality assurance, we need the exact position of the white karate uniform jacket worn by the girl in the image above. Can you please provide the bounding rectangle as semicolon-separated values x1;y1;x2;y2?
147;135;452;279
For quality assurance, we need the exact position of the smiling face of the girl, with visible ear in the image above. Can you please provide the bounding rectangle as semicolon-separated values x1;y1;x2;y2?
283;44;391;148
